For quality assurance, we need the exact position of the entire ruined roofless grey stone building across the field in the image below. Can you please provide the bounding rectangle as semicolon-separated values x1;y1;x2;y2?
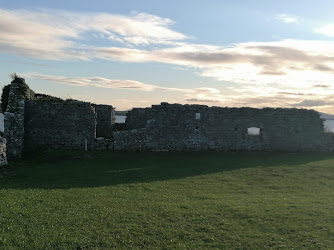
4;77;334;157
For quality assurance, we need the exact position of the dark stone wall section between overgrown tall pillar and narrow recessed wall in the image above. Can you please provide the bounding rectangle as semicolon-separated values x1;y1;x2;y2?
24;100;96;151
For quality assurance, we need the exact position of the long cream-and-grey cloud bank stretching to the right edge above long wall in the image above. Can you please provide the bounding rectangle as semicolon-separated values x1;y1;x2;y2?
94;40;334;89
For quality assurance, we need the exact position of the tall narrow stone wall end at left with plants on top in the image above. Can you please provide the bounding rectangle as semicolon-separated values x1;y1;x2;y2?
4;78;34;158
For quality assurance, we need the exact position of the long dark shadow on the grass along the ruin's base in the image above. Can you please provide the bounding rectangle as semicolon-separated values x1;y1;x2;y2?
0;152;334;189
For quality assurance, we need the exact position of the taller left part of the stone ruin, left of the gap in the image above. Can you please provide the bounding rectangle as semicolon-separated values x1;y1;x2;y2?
4;78;114;158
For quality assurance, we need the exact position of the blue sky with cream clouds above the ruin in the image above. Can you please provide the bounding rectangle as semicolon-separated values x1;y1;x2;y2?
0;0;334;114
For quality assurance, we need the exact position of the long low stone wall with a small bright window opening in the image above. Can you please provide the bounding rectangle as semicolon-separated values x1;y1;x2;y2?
114;103;324;151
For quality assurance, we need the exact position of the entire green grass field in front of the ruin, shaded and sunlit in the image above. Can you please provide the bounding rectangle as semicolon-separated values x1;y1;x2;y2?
0;152;334;249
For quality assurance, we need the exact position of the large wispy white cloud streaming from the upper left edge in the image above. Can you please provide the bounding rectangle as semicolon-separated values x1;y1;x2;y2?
0;9;188;60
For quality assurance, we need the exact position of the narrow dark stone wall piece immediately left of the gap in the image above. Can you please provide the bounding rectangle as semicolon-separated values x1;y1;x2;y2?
95;105;116;139
